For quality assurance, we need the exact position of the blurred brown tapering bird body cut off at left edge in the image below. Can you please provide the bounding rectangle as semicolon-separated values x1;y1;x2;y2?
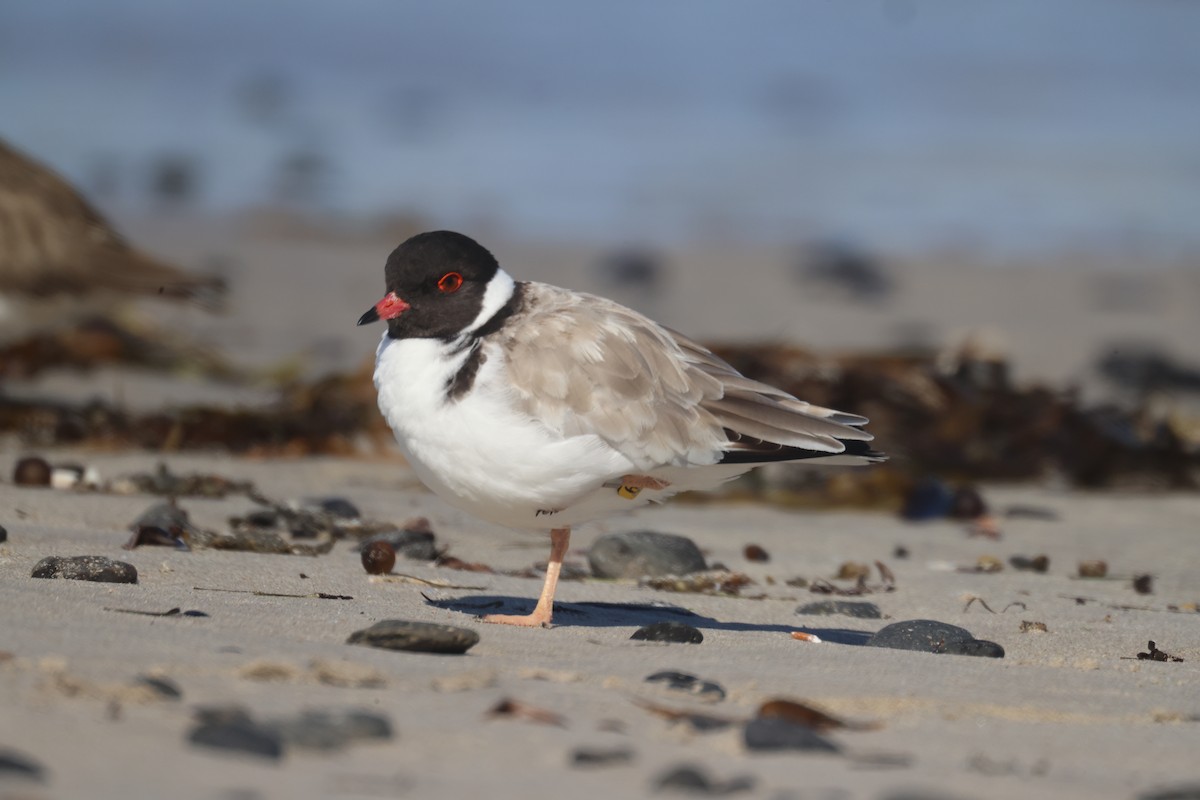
0;139;226;339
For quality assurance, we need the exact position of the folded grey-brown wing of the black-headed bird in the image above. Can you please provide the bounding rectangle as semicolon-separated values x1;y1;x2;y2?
498;283;871;469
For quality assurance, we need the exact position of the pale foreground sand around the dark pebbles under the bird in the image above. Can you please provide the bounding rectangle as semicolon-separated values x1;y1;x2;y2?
0;452;1200;799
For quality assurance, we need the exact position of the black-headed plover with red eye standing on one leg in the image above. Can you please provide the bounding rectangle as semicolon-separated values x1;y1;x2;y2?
358;230;886;627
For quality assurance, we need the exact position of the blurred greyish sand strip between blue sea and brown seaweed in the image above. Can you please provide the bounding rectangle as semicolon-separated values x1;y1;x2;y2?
110;211;1200;402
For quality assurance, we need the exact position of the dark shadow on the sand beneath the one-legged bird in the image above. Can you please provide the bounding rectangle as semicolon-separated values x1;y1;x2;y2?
425;595;874;645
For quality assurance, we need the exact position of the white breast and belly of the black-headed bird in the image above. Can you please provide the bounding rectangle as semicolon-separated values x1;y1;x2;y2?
374;335;641;530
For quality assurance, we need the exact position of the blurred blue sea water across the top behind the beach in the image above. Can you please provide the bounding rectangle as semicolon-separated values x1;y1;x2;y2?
0;0;1200;265
